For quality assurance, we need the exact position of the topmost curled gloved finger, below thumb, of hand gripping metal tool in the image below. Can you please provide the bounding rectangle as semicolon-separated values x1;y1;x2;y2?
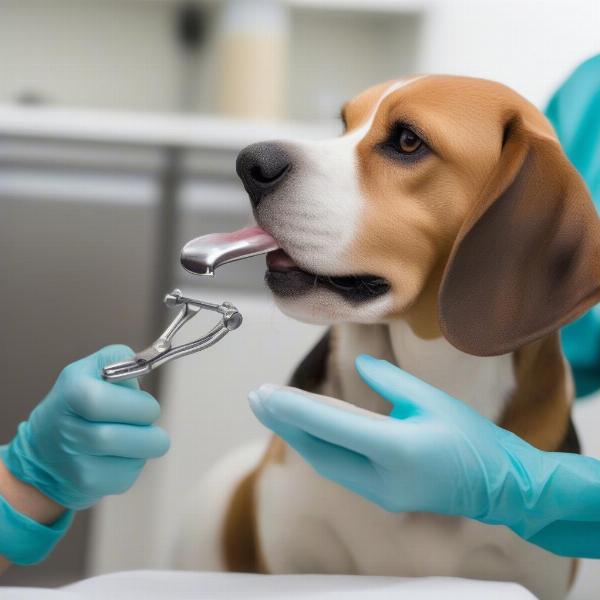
64;378;160;425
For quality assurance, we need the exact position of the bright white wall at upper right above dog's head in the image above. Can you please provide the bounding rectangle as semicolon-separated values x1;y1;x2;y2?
419;0;600;106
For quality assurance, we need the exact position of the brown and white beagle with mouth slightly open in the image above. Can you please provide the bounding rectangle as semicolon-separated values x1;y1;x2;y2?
216;76;600;600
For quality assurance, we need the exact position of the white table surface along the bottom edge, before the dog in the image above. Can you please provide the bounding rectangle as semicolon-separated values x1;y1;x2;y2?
2;571;534;600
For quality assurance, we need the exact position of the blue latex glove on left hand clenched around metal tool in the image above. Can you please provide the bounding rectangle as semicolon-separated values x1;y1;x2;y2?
0;346;169;510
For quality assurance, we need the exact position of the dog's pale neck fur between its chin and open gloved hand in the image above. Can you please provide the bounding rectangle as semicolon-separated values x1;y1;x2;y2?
324;320;516;421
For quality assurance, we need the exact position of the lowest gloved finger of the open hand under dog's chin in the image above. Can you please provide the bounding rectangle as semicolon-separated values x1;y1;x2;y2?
248;392;381;493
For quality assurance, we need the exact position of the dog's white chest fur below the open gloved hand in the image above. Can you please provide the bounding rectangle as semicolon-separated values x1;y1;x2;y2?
256;448;571;600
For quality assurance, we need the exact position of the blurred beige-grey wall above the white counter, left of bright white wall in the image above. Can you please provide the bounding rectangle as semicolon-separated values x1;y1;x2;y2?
0;0;419;119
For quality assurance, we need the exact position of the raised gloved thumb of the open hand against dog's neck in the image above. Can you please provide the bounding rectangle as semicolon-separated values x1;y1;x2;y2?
355;354;448;419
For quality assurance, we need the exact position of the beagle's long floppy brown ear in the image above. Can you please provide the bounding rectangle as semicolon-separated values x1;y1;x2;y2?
439;117;600;356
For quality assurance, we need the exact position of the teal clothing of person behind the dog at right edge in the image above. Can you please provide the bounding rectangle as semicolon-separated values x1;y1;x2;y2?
546;55;600;396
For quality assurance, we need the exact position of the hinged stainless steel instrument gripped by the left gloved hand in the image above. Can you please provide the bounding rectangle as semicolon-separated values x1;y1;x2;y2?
102;289;242;381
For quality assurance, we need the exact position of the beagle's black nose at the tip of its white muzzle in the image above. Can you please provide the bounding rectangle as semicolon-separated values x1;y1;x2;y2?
235;142;292;208
